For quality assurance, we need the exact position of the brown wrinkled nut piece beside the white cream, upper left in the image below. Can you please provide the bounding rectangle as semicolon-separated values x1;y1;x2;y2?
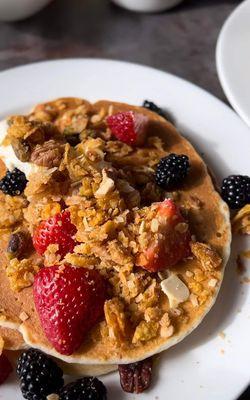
30;139;64;168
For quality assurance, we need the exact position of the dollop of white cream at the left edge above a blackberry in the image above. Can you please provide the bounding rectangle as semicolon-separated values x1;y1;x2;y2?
0;120;39;178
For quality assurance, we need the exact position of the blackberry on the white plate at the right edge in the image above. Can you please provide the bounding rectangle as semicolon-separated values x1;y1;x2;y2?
221;175;250;209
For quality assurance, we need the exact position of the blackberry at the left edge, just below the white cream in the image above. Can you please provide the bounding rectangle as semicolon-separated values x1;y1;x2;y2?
0;168;28;196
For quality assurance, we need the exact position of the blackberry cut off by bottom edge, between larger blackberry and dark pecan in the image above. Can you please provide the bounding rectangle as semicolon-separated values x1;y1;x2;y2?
59;377;107;400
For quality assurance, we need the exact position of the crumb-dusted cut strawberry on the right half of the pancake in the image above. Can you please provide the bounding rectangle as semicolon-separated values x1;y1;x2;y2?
137;199;191;272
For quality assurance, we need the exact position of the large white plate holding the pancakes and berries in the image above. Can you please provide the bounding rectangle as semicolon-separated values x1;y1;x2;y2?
0;59;250;400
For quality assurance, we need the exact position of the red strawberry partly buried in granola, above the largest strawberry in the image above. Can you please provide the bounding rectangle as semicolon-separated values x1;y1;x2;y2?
33;211;76;257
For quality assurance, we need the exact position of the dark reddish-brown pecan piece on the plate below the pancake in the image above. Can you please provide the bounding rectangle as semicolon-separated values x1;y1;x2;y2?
118;358;153;394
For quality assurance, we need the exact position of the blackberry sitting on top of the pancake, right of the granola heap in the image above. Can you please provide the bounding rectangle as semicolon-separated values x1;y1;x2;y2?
155;153;190;190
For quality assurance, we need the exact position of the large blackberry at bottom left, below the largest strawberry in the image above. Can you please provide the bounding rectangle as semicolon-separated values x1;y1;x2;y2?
17;349;64;400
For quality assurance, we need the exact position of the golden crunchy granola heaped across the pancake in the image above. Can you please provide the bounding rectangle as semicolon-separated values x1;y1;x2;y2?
0;99;222;345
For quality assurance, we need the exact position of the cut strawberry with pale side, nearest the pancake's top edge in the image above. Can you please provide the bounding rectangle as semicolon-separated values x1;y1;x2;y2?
107;111;148;146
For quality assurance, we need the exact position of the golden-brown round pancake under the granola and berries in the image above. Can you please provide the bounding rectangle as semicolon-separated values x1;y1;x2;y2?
0;99;231;364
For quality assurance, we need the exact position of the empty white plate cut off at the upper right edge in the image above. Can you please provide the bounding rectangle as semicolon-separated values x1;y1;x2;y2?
216;0;250;126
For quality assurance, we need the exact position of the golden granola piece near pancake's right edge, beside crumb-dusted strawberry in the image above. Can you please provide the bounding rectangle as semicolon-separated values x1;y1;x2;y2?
191;242;222;271
